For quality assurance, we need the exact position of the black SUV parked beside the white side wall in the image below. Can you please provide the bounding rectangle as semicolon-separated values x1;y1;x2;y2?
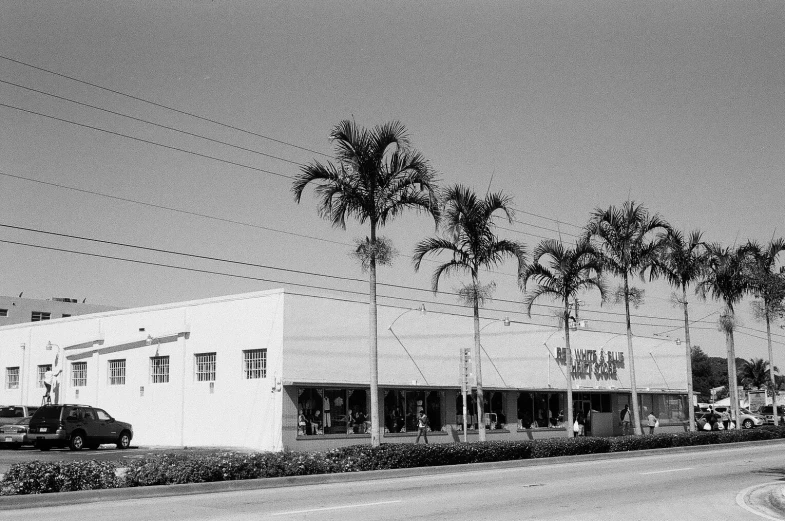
28;404;134;450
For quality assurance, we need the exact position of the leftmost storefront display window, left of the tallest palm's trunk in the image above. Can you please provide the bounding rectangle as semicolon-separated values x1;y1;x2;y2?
297;387;370;436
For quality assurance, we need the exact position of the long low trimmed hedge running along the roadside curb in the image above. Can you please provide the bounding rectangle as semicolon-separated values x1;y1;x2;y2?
0;426;785;495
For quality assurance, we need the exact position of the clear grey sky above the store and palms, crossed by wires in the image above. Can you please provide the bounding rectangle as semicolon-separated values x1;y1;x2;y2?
0;0;785;358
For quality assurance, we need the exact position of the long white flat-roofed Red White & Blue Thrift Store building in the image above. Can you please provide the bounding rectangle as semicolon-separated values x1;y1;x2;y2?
0;290;687;450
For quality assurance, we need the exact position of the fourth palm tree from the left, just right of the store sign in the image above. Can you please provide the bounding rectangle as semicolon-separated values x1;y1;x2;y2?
586;201;670;435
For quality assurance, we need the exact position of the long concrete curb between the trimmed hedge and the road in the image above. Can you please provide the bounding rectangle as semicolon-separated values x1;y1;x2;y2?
0;439;785;510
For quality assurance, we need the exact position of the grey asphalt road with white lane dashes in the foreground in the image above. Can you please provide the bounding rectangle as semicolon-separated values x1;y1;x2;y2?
0;442;785;521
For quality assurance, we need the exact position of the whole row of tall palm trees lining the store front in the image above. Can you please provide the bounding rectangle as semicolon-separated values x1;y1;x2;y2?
292;120;785;446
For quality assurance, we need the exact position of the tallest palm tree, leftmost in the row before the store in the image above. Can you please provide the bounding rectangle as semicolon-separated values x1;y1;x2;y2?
292;120;439;447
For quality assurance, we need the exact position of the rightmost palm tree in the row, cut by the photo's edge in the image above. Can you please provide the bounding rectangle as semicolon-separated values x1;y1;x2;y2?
745;239;785;425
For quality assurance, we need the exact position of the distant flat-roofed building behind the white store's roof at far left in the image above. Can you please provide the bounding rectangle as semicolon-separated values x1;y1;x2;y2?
0;296;120;326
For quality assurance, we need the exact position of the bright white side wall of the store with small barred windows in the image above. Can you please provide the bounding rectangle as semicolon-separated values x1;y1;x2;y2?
0;291;284;450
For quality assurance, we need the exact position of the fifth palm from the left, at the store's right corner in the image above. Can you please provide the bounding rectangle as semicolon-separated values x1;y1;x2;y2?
649;229;706;431
